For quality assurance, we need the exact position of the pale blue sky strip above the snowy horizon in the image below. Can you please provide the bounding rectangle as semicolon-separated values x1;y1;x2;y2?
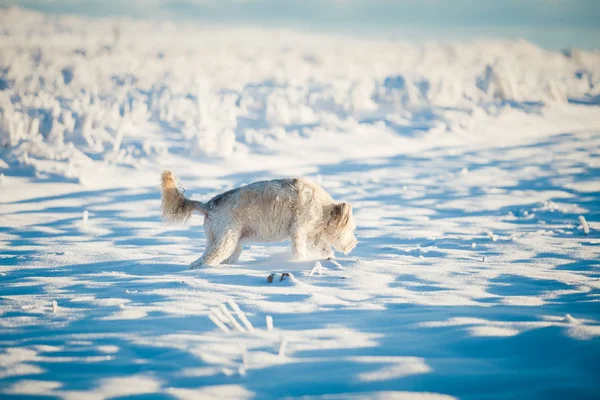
0;0;600;49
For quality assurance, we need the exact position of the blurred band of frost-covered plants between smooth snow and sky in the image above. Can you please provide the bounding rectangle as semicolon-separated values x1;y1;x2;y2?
0;8;600;180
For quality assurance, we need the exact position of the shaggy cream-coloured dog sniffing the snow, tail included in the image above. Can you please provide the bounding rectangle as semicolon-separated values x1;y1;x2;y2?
162;171;358;268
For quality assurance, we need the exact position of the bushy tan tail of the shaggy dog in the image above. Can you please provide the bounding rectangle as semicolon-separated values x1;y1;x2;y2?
161;171;208;222
